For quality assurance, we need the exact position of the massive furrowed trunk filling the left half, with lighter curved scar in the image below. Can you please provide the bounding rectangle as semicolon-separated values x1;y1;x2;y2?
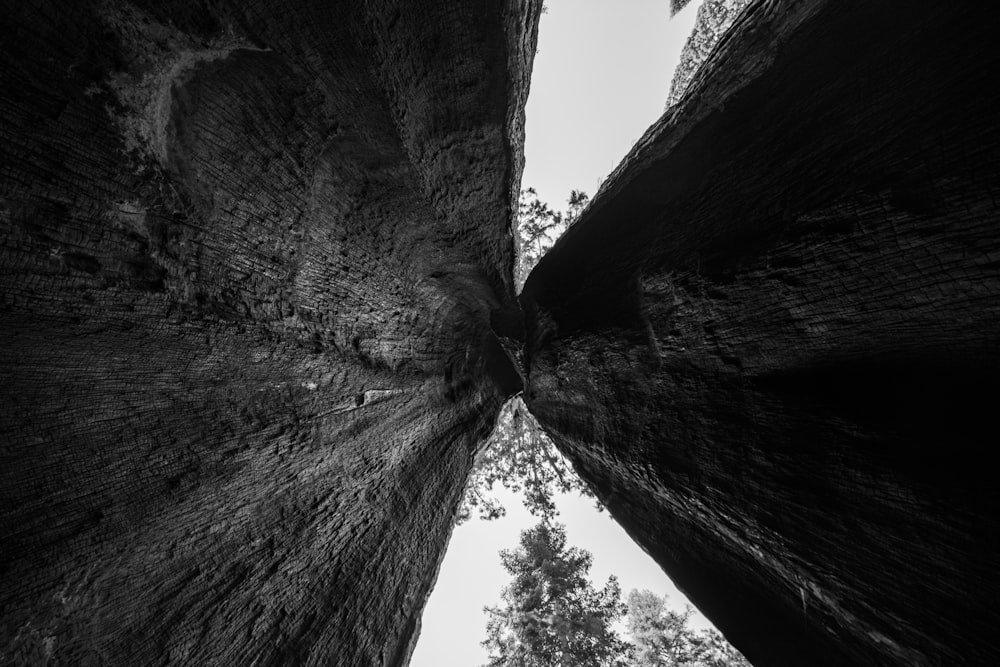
0;0;541;665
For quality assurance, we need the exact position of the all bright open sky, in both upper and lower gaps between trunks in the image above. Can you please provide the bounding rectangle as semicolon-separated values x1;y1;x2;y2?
410;0;711;667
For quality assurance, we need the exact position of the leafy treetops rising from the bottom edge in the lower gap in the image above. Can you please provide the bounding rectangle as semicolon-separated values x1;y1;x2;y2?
483;519;750;667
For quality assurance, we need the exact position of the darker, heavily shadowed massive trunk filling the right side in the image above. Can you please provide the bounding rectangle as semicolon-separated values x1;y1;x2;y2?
521;1;1000;665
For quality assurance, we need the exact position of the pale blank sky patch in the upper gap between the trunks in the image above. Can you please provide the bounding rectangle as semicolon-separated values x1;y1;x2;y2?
521;0;700;210
